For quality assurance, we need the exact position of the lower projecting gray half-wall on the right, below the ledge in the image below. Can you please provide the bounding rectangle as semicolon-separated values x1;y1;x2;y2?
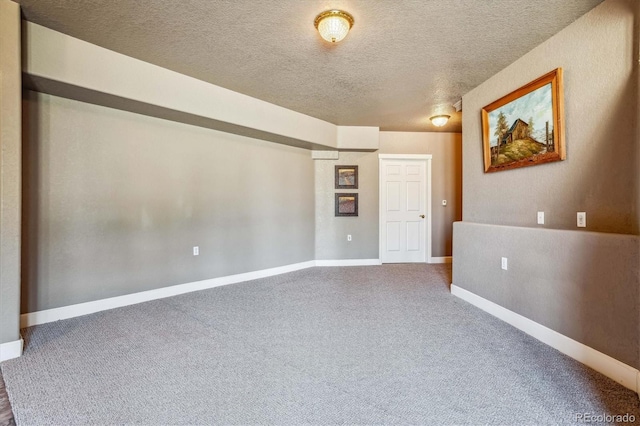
453;222;640;367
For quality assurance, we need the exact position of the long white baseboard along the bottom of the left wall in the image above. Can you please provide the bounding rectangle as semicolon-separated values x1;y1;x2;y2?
20;260;316;328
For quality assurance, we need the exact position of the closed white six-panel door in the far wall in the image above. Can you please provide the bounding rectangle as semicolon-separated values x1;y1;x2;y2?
380;155;431;263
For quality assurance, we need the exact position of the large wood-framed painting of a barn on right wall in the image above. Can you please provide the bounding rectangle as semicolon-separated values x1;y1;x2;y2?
482;68;566;172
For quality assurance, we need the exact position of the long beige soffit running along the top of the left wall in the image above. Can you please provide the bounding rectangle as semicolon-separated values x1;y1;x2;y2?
23;22;337;148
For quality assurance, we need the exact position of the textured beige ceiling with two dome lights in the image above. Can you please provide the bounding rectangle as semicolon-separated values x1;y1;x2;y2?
17;0;602;131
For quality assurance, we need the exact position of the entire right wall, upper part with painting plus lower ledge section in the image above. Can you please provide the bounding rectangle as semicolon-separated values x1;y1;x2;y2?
453;0;640;367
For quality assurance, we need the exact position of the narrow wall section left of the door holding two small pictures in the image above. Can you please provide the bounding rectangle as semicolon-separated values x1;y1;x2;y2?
314;152;379;260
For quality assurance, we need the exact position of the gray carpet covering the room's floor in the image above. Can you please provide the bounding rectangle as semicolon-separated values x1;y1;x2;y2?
1;264;640;425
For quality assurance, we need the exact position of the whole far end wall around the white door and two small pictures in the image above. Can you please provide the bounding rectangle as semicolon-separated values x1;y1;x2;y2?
315;132;462;260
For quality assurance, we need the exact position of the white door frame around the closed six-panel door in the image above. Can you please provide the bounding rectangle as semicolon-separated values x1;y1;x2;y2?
378;154;433;263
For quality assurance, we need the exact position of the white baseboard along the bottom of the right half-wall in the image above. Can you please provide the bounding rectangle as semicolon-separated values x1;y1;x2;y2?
451;284;640;393
